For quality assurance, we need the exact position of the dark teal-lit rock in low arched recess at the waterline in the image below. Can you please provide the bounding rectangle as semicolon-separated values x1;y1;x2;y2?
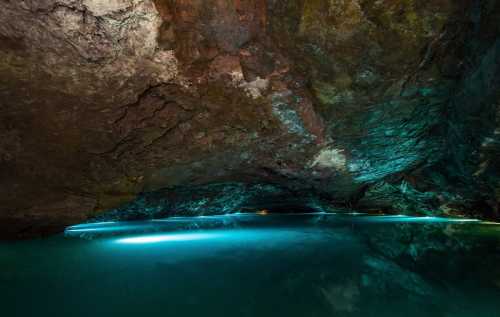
92;183;338;221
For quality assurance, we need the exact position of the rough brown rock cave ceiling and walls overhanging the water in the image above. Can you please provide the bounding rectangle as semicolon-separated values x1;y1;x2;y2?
0;0;500;233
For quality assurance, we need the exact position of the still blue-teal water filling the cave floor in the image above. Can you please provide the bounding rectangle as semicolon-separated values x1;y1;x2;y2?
0;214;500;317
